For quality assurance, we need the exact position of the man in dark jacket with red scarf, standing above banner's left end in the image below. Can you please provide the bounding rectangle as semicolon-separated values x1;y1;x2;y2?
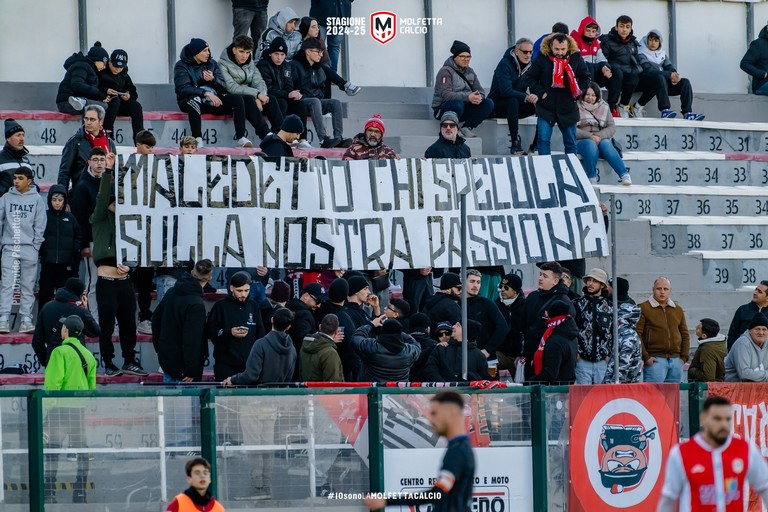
58;105;116;189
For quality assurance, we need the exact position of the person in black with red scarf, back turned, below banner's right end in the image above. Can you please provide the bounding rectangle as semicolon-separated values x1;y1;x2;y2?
530;302;579;385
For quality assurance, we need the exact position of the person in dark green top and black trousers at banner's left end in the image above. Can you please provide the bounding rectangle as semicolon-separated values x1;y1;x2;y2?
90;158;148;377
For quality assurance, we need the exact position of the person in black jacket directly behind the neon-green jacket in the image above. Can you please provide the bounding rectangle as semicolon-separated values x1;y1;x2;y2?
32;277;101;366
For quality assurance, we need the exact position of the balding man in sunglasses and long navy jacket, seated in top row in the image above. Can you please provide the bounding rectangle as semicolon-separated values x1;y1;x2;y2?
488;37;538;155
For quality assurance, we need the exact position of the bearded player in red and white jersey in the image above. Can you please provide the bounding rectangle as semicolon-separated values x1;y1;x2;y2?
656;396;768;512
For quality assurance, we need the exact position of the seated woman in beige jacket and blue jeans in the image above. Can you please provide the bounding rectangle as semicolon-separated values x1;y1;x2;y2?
576;82;632;186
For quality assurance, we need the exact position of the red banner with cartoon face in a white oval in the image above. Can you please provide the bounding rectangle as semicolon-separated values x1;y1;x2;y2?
568;384;680;512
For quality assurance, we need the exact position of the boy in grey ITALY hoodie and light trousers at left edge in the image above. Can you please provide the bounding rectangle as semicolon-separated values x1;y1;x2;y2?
0;167;46;333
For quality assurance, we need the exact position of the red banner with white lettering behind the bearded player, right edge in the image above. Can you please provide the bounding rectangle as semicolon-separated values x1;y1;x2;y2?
707;382;768;512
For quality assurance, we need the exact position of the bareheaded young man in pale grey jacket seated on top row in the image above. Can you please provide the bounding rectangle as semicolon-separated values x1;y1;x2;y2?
219;36;283;140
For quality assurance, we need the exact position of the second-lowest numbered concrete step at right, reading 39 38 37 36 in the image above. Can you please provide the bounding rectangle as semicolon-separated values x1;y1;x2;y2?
637;216;768;255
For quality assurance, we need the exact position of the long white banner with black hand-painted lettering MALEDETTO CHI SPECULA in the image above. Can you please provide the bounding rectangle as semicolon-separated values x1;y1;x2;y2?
115;155;608;270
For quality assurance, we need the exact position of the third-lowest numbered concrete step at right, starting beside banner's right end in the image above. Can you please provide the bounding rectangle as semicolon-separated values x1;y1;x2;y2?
596;185;768;220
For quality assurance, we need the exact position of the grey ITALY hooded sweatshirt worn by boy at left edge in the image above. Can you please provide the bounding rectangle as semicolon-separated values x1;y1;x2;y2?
0;182;47;260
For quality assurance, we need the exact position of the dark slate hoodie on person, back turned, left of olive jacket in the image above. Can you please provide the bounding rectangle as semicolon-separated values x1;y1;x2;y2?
231;330;296;386
